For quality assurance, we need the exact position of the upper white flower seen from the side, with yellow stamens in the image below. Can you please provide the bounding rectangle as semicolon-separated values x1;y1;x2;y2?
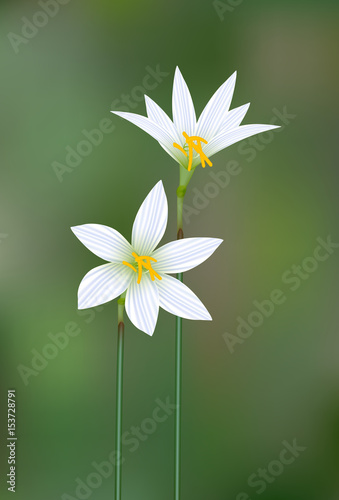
112;67;279;170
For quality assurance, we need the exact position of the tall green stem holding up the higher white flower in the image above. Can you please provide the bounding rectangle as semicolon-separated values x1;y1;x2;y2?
174;166;194;500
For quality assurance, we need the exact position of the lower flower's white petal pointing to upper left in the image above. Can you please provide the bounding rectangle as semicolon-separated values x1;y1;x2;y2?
71;224;133;263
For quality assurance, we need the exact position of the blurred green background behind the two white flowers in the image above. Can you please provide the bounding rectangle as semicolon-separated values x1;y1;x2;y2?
0;0;339;500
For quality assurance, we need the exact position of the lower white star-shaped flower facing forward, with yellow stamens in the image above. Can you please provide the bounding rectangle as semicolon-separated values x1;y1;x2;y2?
71;181;222;335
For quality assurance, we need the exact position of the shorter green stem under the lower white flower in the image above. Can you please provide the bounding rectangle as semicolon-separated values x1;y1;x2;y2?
115;294;125;500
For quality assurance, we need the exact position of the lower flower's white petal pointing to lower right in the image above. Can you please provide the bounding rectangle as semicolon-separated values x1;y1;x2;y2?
156;274;212;321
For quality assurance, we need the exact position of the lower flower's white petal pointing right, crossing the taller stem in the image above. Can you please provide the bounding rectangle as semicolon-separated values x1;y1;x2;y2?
152;238;223;274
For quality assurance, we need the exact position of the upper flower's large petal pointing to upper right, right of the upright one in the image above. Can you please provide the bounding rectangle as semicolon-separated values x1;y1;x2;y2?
196;72;237;141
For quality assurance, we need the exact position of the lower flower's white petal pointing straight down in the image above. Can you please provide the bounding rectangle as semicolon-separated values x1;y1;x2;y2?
125;271;159;335
